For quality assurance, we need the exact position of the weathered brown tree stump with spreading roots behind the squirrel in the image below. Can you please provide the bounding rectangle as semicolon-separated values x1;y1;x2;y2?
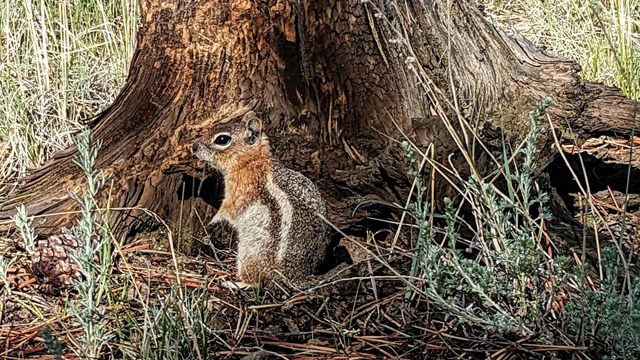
2;0;634;248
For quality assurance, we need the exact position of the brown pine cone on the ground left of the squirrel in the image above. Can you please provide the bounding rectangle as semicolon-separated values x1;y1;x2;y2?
31;234;99;295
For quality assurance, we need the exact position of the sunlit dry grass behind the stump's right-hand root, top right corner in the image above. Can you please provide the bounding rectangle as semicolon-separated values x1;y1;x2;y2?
478;0;640;99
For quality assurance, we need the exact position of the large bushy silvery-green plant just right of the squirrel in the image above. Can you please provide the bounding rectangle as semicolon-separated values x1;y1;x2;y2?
403;98;568;334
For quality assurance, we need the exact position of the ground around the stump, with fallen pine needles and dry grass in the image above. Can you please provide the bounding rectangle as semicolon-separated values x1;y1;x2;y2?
0;0;640;359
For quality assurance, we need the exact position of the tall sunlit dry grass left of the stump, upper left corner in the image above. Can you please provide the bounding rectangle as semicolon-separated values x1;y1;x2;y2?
0;0;139;181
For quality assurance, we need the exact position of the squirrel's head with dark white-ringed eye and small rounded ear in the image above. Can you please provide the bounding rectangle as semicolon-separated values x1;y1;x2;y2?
193;117;270;173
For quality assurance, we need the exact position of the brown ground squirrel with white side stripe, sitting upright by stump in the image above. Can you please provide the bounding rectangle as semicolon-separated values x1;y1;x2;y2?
193;116;330;287
